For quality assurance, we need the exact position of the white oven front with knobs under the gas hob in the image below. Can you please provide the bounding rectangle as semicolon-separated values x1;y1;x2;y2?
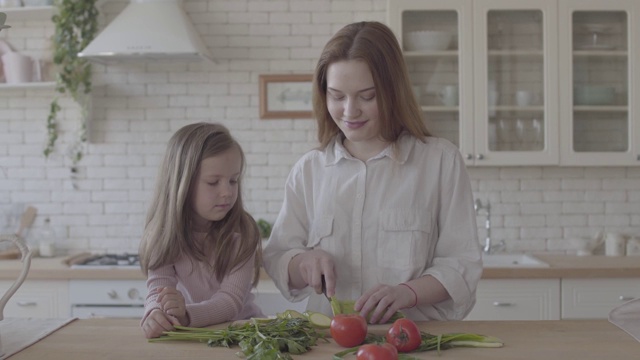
69;280;147;319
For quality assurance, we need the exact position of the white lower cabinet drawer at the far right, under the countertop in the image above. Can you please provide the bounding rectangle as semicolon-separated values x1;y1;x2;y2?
562;279;640;319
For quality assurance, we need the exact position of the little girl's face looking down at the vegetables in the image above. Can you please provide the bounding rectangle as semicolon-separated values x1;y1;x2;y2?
191;148;242;231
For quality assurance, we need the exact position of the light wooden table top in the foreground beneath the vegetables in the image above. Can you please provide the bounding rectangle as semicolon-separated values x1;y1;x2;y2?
10;319;640;360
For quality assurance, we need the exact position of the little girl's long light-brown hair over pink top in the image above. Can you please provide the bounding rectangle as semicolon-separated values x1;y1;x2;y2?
139;123;262;286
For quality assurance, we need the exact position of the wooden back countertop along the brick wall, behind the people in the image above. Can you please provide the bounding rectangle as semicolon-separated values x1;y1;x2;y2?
0;254;640;280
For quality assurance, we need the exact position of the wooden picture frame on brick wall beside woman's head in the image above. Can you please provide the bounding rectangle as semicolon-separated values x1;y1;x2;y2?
259;74;313;119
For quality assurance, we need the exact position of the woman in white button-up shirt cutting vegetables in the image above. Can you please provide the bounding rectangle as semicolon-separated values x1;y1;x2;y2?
264;22;482;323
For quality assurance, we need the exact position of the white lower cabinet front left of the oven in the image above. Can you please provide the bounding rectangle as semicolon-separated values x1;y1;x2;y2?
0;279;69;318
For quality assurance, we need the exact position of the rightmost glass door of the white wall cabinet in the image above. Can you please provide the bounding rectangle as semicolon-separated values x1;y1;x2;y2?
559;0;640;166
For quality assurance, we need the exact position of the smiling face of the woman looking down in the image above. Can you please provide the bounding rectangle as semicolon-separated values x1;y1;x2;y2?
327;60;380;143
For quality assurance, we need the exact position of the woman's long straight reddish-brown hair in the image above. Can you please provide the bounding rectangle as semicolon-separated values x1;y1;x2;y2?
312;21;431;149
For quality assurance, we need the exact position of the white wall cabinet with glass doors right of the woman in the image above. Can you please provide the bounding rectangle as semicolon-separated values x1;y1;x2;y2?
388;0;640;166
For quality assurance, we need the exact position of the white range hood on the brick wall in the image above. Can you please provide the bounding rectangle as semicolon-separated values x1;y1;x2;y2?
78;0;213;63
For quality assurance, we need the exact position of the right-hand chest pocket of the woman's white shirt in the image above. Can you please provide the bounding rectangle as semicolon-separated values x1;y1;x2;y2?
377;209;433;270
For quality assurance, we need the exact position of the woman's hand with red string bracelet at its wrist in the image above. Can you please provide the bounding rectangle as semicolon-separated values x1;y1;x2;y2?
354;284;416;324
